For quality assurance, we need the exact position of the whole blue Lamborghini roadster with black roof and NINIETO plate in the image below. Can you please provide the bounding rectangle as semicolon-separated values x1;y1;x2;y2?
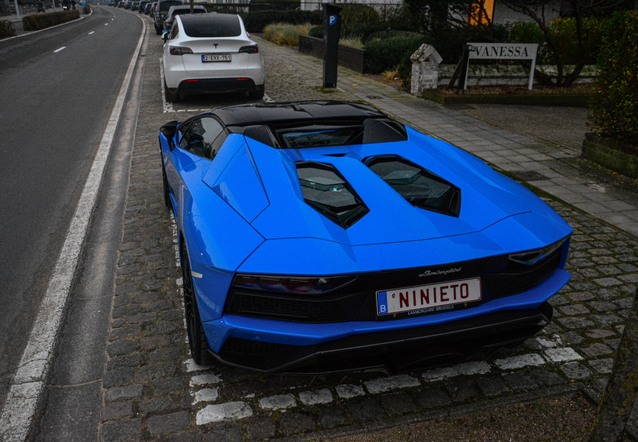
159;102;572;373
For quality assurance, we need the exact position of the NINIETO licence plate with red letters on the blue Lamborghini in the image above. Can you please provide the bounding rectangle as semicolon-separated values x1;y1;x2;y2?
377;278;481;316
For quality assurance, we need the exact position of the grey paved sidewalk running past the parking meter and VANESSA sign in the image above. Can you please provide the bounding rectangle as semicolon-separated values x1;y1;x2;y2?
260;40;638;236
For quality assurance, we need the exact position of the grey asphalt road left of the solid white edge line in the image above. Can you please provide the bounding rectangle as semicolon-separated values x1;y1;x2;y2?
0;8;142;403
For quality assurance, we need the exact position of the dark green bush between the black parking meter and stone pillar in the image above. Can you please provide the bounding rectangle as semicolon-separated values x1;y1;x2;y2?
365;36;425;74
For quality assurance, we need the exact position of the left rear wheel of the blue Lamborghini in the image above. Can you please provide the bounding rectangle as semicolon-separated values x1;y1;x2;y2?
182;243;208;365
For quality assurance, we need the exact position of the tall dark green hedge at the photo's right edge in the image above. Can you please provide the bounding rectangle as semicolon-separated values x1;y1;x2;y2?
591;11;638;146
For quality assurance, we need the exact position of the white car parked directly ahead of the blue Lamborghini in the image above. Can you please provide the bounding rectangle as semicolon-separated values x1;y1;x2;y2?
163;13;265;101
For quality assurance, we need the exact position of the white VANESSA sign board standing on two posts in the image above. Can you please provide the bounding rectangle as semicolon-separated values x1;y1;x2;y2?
463;43;538;90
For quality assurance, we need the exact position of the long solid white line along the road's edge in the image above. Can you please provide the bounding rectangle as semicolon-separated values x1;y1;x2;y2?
0;20;146;441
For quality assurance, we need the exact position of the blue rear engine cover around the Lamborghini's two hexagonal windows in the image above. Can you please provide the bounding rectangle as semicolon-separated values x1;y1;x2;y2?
204;128;571;249
